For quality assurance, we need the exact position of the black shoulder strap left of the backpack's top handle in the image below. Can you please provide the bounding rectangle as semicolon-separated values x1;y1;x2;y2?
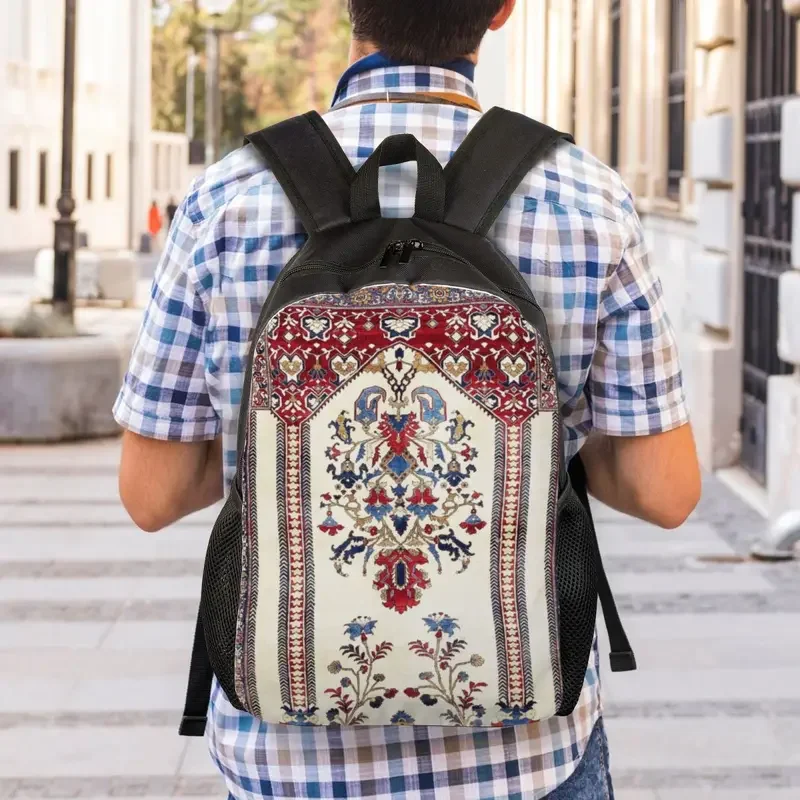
245;111;356;235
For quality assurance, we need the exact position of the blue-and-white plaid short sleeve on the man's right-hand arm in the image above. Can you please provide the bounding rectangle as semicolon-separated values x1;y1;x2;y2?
588;200;689;436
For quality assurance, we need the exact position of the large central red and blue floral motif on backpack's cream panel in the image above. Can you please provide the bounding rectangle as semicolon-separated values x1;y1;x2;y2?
318;346;486;614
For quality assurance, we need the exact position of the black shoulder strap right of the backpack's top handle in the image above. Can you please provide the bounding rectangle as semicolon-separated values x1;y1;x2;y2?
444;108;574;236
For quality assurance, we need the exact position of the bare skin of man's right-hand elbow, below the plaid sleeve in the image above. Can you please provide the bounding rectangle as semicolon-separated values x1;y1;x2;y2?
581;424;702;529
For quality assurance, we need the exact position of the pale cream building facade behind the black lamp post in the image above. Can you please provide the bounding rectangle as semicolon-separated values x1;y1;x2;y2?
0;0;151;251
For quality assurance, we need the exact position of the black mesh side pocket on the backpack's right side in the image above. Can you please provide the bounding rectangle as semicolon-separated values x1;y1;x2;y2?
556;484;597;716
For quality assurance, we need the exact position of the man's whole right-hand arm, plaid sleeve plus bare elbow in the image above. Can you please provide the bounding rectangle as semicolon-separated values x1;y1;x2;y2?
581;194;701;528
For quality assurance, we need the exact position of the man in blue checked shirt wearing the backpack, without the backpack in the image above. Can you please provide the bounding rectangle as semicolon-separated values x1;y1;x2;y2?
116;0;700;800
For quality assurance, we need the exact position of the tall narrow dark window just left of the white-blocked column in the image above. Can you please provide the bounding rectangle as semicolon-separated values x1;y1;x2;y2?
667;0;686;200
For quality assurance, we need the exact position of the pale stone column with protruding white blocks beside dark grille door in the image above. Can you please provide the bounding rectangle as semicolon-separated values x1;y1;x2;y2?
689;0;746;469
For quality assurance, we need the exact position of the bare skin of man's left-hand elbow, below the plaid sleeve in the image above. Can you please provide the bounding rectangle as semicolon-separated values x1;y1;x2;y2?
119;431;223;533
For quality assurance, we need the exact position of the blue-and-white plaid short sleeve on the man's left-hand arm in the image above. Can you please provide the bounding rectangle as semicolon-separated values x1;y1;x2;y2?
114;195;221;442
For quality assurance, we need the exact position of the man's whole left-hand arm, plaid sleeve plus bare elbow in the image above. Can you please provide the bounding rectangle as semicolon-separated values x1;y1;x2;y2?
114;184;223;531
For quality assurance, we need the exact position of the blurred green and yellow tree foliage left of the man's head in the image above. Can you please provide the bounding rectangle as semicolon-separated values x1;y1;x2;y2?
153;0;349;152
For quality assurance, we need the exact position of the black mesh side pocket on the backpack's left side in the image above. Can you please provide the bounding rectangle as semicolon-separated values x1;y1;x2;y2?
200;482;242;708
